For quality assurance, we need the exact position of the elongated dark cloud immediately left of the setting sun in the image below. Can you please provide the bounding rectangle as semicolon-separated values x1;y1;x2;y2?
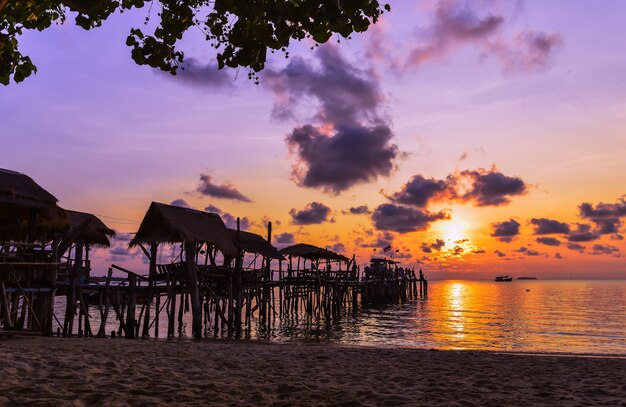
372;204;450;233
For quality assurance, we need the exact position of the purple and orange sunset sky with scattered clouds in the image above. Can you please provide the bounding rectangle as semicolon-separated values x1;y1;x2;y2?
0;0;626;279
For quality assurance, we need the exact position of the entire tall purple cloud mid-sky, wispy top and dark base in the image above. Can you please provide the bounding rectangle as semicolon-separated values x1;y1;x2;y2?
263;45;400;194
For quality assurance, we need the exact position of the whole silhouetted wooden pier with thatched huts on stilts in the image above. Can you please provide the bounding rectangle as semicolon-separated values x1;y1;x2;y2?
0;170;428;338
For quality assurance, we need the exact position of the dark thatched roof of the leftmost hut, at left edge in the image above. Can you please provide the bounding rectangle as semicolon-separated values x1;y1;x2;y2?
0;169;67;240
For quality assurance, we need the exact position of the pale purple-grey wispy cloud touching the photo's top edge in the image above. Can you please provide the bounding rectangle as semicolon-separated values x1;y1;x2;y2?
407;0;504;67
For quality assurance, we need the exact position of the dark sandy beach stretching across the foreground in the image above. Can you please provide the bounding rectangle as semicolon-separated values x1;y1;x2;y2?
0;336;626;406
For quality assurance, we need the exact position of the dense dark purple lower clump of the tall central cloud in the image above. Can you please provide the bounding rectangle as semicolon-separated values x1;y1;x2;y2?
286;124;398;194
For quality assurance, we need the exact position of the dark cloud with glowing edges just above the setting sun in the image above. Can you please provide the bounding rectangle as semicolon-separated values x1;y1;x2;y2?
447;167;527;206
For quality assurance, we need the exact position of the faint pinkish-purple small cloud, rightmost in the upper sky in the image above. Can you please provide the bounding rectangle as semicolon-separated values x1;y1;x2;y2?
487;31;563;72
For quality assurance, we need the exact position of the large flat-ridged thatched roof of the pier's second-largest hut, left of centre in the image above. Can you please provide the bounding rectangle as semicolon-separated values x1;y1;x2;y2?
130;202;237;256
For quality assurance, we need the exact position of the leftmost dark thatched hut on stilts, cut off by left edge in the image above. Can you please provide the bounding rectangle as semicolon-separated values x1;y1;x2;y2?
0;169;67;333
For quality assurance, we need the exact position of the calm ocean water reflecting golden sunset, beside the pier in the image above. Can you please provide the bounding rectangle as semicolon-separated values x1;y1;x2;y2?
78;280;626;355
